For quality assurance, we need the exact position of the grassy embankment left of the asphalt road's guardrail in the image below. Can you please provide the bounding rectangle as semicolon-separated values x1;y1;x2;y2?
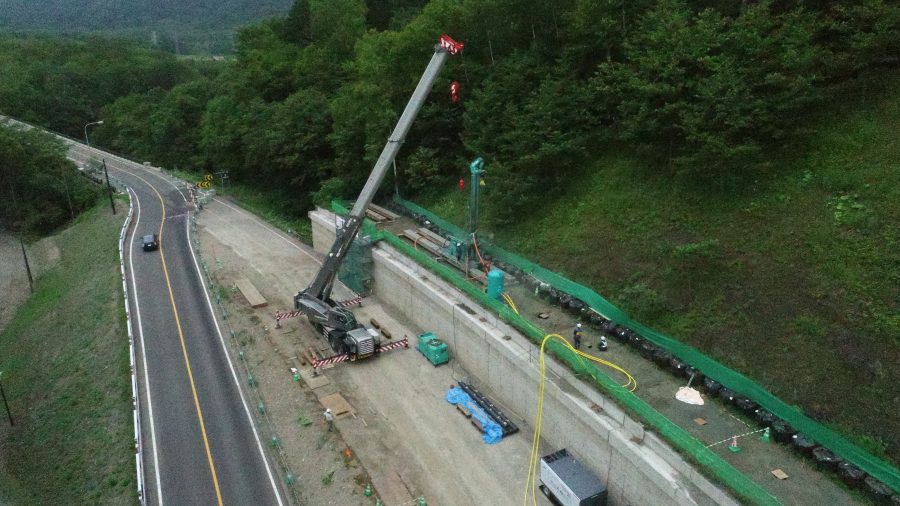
0;206;136;504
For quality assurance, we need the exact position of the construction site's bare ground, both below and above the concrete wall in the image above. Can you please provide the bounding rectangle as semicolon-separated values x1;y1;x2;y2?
192;194;865;505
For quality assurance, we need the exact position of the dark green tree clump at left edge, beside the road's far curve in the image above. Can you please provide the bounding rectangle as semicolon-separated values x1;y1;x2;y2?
0;127;100;235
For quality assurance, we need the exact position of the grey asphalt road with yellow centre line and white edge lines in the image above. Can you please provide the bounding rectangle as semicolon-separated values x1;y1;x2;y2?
44;129;288;505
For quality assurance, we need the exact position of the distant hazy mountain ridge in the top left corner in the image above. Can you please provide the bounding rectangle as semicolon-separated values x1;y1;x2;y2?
0;0;293;33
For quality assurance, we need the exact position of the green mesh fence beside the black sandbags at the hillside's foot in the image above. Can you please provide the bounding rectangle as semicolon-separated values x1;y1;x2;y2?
394;197;900;491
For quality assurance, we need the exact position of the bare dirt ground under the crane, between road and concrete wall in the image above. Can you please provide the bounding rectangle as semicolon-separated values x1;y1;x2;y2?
197;199;549;506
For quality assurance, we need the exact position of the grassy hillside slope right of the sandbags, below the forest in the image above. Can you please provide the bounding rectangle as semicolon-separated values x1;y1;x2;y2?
431;73;900;463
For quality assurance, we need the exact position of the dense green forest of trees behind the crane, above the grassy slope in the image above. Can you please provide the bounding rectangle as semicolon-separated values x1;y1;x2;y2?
0;0;900;229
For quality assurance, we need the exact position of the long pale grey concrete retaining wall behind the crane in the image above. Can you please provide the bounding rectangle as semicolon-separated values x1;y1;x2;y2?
310;210;738;505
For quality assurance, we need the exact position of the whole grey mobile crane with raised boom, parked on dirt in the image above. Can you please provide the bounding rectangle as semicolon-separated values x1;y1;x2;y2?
294;35;463;360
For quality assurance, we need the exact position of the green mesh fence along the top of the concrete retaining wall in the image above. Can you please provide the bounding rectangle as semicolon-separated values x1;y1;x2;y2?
332;202;781;505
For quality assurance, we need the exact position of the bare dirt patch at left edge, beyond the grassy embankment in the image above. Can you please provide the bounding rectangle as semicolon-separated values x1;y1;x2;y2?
0;230;59;330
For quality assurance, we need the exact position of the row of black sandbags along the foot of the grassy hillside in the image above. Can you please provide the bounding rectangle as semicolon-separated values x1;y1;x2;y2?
396;209;900;506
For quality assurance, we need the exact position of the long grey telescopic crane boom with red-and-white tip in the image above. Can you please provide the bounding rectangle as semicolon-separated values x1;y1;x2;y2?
294;35;463;348
